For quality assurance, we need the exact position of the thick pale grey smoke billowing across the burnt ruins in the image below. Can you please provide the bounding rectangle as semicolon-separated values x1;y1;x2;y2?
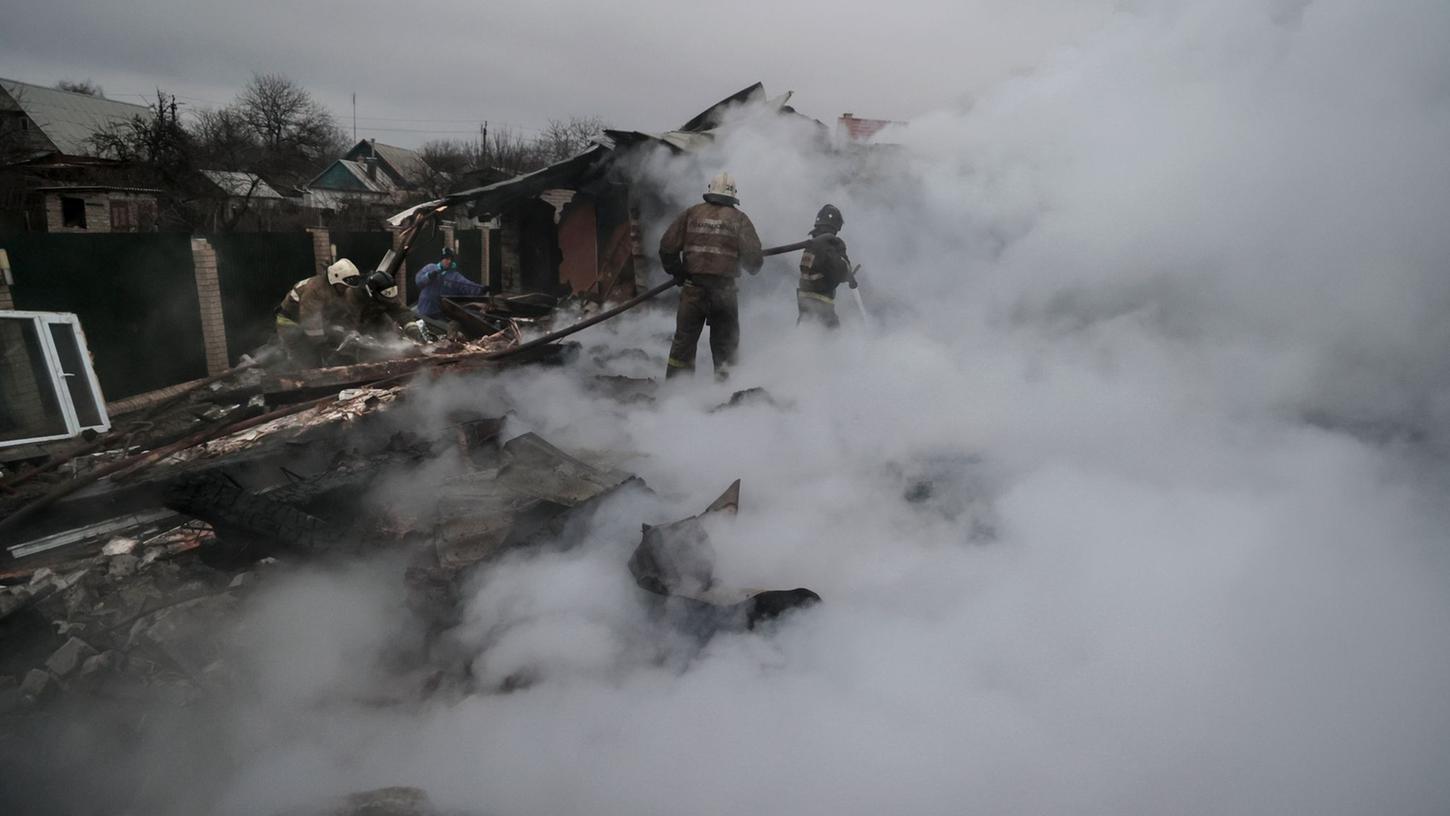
11;0;1450;815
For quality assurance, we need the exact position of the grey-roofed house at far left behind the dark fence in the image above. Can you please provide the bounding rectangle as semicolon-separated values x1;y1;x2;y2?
0;78;160;232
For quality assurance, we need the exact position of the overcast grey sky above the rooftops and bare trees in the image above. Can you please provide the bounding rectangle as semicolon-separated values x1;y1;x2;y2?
0;0;1114;145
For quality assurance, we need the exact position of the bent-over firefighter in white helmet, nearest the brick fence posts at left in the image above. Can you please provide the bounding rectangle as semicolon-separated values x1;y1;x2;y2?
277;258;363;368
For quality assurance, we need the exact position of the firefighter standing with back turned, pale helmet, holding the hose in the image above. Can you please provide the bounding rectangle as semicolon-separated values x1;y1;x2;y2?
660;172;764;380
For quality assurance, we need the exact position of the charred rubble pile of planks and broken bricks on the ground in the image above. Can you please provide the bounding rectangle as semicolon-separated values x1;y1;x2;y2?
0;294;821;813
